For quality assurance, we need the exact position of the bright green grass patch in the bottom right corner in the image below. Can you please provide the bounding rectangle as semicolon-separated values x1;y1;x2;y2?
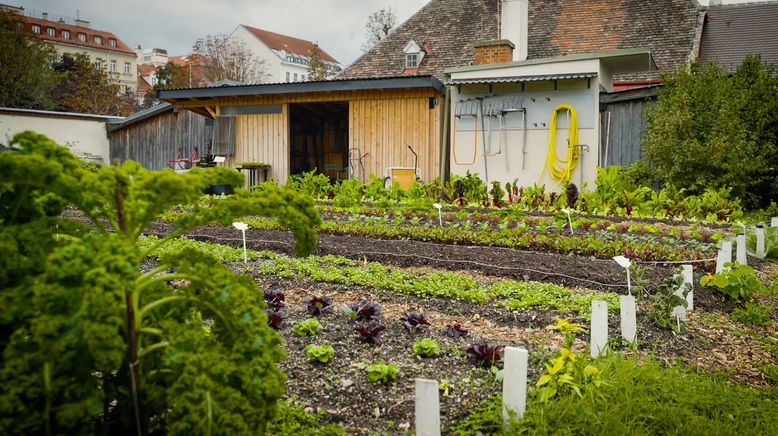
452;354;778;435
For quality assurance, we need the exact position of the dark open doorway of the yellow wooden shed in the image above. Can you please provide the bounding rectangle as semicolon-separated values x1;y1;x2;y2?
289;102;348;181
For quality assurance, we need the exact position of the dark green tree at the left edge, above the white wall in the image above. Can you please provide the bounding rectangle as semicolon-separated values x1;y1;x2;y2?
0;9;58;109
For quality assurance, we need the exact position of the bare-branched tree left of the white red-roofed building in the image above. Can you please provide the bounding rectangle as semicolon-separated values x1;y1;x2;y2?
192;34;268;86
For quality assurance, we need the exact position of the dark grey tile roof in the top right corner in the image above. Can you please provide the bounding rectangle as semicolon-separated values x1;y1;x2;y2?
700;2;778;71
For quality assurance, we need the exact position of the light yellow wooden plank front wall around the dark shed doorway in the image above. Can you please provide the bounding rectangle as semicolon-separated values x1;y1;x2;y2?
212;89;443;183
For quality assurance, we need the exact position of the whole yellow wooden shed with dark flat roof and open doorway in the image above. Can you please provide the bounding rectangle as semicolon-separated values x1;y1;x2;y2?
159;76;444;183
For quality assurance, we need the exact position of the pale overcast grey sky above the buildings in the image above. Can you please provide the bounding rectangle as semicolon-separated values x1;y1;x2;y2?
16;0;764;65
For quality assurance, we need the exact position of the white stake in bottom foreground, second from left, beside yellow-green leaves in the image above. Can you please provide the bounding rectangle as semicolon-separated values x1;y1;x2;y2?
502;347;529;430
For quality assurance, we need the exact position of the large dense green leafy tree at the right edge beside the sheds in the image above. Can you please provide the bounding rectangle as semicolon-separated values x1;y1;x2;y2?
644;56;778;208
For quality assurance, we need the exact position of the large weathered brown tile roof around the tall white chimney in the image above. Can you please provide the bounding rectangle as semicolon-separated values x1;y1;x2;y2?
339;0;700;80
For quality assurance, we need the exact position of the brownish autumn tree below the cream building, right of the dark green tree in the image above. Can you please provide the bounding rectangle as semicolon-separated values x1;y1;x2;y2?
54;53;134;116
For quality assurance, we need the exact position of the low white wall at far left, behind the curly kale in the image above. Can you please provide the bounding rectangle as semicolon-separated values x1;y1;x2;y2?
0;109;109;163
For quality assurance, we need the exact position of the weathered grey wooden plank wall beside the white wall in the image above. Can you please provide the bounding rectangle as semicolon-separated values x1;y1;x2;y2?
108;110;212;170
